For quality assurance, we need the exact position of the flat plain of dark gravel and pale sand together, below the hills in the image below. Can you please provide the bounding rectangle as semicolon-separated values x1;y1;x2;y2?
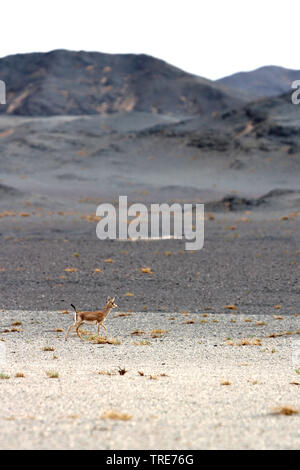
0;208;300;450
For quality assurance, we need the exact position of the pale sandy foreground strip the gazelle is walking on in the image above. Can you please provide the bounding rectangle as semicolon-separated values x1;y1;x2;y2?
0;310;300;449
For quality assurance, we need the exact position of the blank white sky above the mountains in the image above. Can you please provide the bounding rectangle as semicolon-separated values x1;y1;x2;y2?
0;0;300;79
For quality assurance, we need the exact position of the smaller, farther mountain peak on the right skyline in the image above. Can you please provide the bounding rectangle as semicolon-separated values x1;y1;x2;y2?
216;65;300;98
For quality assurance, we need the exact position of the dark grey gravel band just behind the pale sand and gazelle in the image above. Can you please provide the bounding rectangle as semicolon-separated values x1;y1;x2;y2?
0;214;300;314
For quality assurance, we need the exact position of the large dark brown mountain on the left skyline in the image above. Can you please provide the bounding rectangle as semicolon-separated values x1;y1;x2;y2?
0;50;245;116
